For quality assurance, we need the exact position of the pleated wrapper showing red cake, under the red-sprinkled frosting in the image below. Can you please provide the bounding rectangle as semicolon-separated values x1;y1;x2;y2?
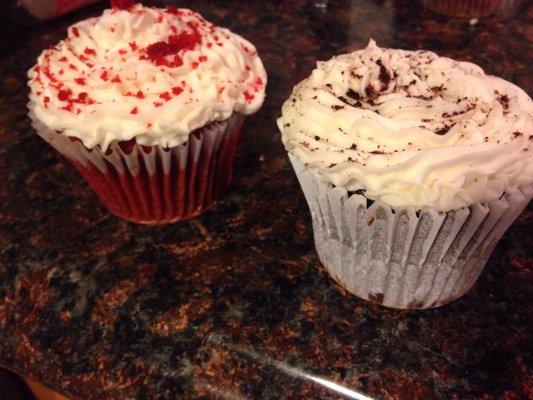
30;106;244;224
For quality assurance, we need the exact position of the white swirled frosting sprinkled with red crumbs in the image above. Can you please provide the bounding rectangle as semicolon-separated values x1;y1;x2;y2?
28;5;266;149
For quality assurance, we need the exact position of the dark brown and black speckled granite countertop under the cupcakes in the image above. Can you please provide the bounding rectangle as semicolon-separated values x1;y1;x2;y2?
0;0;533;400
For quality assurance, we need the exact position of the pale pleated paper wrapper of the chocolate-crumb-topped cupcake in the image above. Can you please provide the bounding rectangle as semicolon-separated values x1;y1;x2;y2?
289;155;533;308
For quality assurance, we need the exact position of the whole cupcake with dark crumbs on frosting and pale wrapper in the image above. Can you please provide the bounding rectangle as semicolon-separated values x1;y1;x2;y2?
278;41;533;308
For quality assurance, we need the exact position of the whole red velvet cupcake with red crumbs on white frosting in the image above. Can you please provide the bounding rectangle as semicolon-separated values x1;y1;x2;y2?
28;1;266;224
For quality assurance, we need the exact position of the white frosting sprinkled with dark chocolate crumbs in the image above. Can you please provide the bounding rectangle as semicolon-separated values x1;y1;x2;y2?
278;41;533;211
